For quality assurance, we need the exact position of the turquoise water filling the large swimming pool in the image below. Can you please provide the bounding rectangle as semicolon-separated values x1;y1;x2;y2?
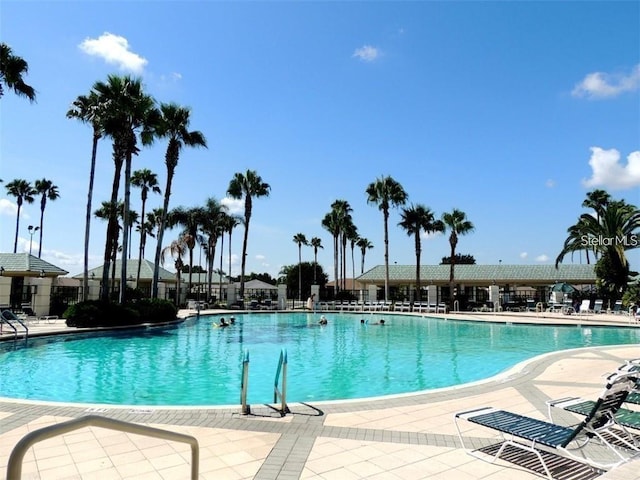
0;313;640;405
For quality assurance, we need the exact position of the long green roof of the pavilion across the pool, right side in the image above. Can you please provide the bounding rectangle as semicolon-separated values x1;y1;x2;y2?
356;264;596;285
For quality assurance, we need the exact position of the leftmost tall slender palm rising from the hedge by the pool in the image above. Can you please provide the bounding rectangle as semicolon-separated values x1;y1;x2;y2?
67;91;108;302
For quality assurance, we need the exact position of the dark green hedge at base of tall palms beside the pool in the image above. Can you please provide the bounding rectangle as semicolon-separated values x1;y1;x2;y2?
64;299;177;327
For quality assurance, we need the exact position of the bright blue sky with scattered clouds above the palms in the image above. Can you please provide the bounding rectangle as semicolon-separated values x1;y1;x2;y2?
0;1;640;276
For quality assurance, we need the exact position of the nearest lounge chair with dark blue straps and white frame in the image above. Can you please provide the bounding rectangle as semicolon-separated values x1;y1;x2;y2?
454;372;640;479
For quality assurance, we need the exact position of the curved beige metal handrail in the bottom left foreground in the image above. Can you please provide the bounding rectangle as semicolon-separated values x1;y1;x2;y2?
7;415;200;480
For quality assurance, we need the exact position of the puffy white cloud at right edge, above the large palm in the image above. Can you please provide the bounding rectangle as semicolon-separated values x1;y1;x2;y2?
582;147;640;190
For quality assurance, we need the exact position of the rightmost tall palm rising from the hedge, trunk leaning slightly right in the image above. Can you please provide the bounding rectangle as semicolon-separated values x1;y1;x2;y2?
151;103;207;298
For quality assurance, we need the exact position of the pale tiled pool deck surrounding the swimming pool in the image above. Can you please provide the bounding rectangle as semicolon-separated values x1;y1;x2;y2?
0;311;640;480
